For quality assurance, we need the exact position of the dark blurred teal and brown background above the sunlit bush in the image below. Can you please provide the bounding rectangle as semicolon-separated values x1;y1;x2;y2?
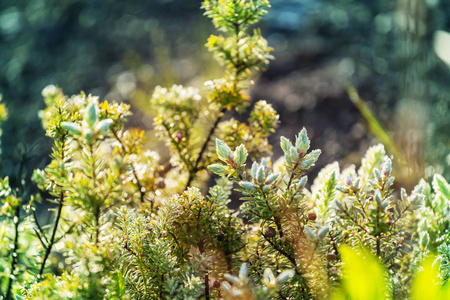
0;0;450;189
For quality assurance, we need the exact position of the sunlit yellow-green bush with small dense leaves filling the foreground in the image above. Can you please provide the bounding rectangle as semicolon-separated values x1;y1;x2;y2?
0;0;450;300
